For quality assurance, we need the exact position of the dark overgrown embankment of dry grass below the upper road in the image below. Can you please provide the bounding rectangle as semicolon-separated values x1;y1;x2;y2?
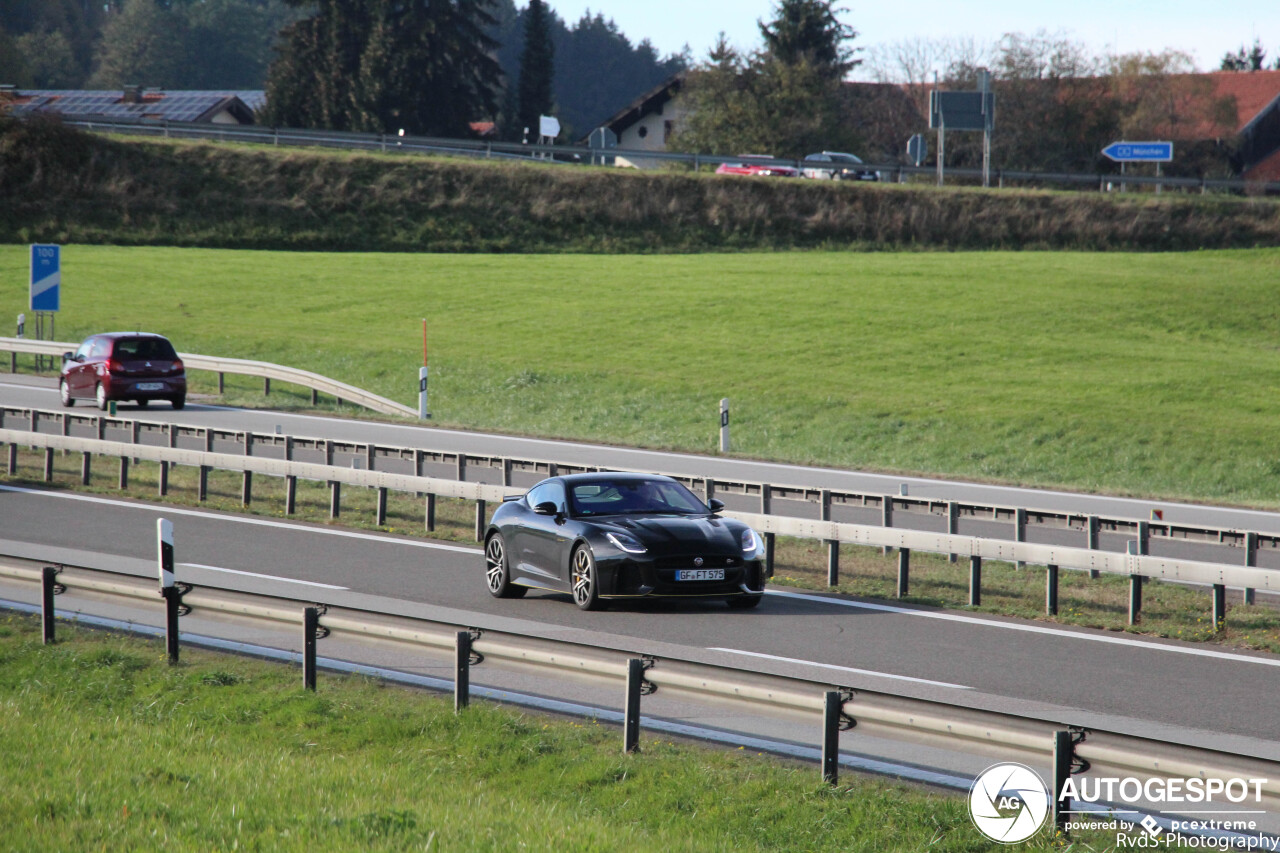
0;114;1280;251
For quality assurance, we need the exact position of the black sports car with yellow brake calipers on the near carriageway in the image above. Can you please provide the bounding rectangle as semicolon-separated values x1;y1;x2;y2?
484;473;765;610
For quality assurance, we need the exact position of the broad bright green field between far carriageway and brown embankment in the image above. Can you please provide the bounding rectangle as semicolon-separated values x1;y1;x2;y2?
0;240;1280;506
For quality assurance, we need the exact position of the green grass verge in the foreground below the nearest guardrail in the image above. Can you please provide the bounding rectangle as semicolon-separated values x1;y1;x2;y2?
0;616;1112;852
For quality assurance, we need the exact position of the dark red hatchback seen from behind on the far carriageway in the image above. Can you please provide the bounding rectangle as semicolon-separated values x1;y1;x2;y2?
58;332;187;410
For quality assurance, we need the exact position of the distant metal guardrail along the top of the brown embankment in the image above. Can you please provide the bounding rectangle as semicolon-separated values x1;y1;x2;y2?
55;115;1280;193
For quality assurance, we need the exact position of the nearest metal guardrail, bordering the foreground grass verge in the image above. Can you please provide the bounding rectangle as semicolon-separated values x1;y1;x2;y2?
0;552;1280;820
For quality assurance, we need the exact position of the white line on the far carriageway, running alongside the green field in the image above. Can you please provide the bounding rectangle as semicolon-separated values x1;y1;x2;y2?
0;383;1276;524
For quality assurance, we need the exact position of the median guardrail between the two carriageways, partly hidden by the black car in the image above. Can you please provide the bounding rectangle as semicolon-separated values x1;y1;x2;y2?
0;407;1280;625
